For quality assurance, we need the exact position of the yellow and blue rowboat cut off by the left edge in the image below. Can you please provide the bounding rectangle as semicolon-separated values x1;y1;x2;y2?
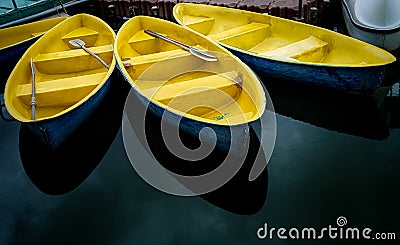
0;16;67;92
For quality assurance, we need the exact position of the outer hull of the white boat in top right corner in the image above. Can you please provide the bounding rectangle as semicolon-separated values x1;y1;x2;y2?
342;0;400;51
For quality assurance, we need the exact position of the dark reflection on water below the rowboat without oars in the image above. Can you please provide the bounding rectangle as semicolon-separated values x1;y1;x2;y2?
262;74;390;140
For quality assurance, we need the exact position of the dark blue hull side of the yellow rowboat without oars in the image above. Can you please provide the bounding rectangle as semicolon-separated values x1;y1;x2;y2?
227;47;387;94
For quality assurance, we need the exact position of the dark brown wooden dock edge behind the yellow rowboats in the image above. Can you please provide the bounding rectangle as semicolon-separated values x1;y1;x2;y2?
97;0;324;24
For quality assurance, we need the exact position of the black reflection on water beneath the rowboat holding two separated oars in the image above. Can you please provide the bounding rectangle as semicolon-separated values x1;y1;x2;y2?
19;72;129;195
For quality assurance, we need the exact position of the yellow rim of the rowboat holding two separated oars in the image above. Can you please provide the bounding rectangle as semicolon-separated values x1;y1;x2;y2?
4;13;116;123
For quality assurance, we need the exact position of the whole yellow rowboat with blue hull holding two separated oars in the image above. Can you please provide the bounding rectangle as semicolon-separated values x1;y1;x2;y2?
4;14;115;148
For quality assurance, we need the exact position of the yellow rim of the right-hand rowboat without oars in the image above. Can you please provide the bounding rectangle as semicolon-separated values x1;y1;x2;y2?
173;2;397;68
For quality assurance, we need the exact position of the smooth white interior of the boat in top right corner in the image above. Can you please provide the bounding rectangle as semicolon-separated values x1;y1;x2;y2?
342;0;400;31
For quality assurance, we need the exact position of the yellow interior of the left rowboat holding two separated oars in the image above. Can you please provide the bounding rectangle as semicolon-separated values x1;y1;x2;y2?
4;14;116;122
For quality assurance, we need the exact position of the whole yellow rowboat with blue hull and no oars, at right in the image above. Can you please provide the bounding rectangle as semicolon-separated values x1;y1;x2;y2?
173;3;396;94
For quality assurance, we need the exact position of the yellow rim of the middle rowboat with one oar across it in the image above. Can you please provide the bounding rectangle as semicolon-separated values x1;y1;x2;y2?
114;16;267;127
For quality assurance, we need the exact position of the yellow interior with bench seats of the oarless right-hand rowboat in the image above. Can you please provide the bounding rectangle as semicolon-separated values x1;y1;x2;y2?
173;3;396;67
